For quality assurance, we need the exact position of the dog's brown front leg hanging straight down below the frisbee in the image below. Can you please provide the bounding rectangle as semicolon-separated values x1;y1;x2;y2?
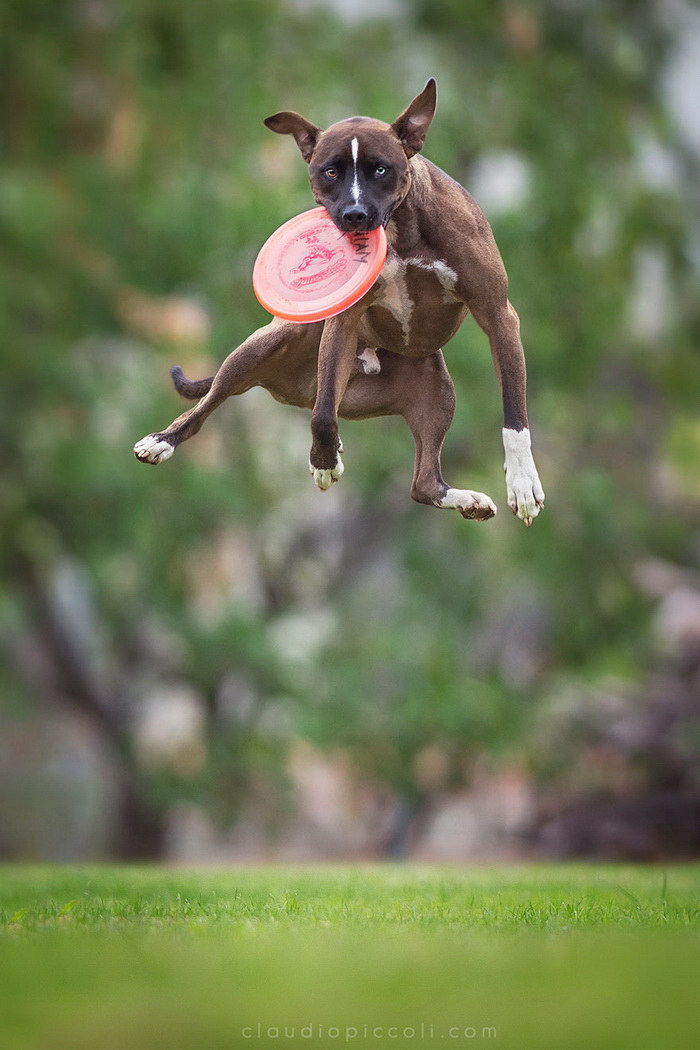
309;309;359;491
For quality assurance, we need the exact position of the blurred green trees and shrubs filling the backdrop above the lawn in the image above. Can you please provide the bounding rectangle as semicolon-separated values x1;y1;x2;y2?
0;0;700;860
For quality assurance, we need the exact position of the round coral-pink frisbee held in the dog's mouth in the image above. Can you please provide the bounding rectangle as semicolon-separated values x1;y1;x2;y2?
253;208;386;324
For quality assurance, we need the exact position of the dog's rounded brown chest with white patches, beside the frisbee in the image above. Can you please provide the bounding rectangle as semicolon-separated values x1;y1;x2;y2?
360;255;468;357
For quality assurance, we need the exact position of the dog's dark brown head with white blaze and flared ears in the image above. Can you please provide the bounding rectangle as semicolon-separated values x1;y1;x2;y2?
264;78;437;233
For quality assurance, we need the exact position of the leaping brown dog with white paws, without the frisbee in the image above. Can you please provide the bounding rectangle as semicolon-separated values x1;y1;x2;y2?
134;78;545;527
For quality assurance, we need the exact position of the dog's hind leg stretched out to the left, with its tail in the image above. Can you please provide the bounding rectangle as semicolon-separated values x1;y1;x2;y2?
133;321;291;464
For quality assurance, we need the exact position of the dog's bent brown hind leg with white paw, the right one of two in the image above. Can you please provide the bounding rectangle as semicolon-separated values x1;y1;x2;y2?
401;352;496;521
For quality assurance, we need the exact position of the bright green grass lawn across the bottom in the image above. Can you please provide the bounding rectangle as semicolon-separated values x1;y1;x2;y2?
0;865;700;1050
